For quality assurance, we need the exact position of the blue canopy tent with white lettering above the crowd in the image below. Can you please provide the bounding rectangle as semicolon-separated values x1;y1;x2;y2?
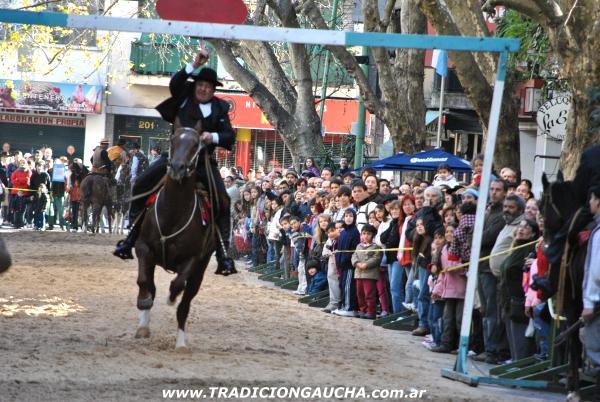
369;148;471;173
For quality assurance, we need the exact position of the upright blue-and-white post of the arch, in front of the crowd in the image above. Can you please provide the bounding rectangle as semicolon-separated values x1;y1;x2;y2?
454;51;508;374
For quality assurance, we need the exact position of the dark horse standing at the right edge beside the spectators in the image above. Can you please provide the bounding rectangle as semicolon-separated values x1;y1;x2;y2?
541;172;593;393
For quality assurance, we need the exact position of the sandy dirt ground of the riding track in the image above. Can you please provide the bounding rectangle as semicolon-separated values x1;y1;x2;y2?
0;231;562;401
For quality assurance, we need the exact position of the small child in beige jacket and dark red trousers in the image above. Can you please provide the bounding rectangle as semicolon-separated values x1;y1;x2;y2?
352;223;381;320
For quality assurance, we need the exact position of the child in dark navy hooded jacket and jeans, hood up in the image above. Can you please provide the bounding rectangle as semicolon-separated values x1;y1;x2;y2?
333;208;360;317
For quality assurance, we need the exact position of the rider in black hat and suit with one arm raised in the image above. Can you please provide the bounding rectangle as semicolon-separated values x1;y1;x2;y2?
113;50;237;275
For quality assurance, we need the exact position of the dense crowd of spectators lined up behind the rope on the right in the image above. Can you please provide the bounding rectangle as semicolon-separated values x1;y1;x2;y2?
224;156;550;364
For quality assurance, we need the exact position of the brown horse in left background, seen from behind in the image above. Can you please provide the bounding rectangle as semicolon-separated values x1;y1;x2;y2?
79;173;112;233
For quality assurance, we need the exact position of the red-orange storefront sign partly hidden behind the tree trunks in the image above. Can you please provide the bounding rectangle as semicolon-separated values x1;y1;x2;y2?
217;93;369;134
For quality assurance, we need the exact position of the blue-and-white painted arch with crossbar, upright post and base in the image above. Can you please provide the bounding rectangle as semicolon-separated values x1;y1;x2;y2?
0;9;524;387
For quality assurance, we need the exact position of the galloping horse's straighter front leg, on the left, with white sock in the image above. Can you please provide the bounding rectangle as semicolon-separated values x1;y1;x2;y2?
135;244;156;338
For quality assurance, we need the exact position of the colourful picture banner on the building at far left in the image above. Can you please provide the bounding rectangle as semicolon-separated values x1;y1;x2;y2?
0;79;102;114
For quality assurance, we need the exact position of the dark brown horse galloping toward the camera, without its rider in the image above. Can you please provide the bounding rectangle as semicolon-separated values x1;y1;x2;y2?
135;127;216;349
